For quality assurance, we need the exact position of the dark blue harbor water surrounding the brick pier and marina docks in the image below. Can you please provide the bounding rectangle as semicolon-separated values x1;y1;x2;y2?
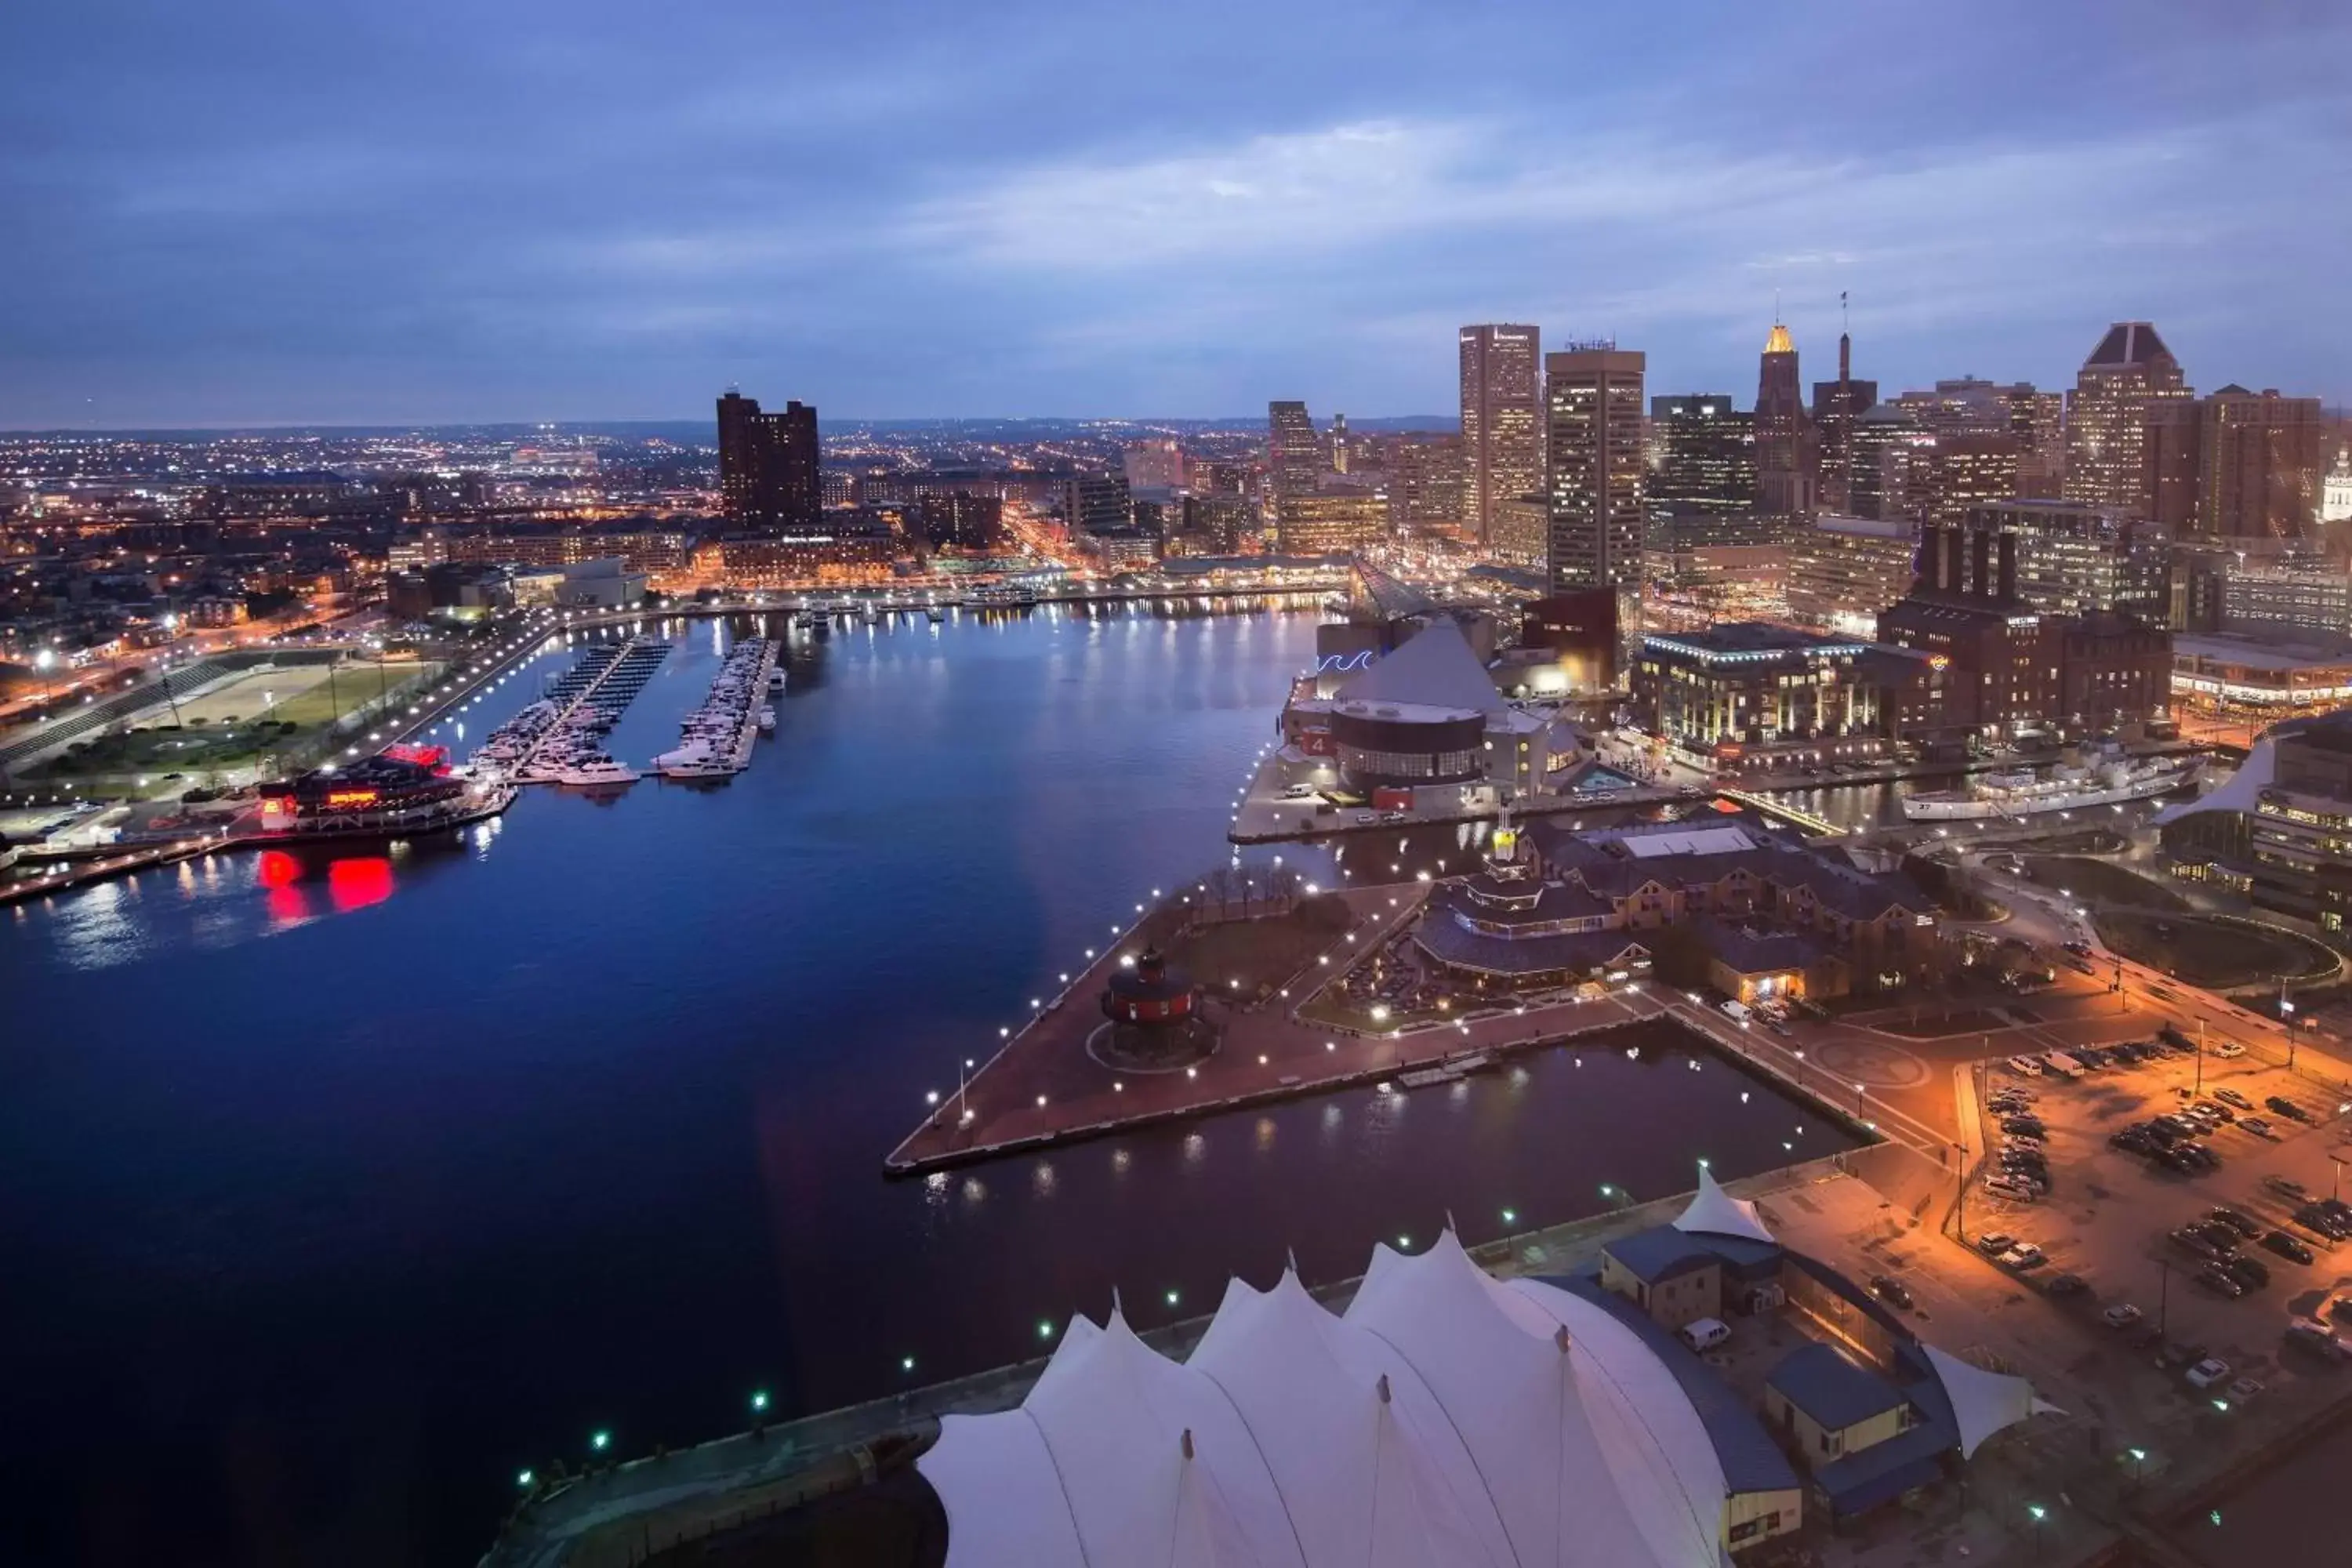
0;607;1842;1563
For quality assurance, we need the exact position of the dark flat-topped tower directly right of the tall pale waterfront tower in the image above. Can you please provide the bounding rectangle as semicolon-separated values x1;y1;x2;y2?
1543;343;1644;597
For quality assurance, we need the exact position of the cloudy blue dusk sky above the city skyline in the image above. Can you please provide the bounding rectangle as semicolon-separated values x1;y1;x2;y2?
0;0;2352;428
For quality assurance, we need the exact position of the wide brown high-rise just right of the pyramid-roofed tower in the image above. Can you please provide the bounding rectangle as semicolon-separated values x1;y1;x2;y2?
2145;386;2326;541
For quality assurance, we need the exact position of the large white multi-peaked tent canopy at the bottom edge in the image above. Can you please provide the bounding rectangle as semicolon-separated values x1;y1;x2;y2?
917;1232;1724;1568
